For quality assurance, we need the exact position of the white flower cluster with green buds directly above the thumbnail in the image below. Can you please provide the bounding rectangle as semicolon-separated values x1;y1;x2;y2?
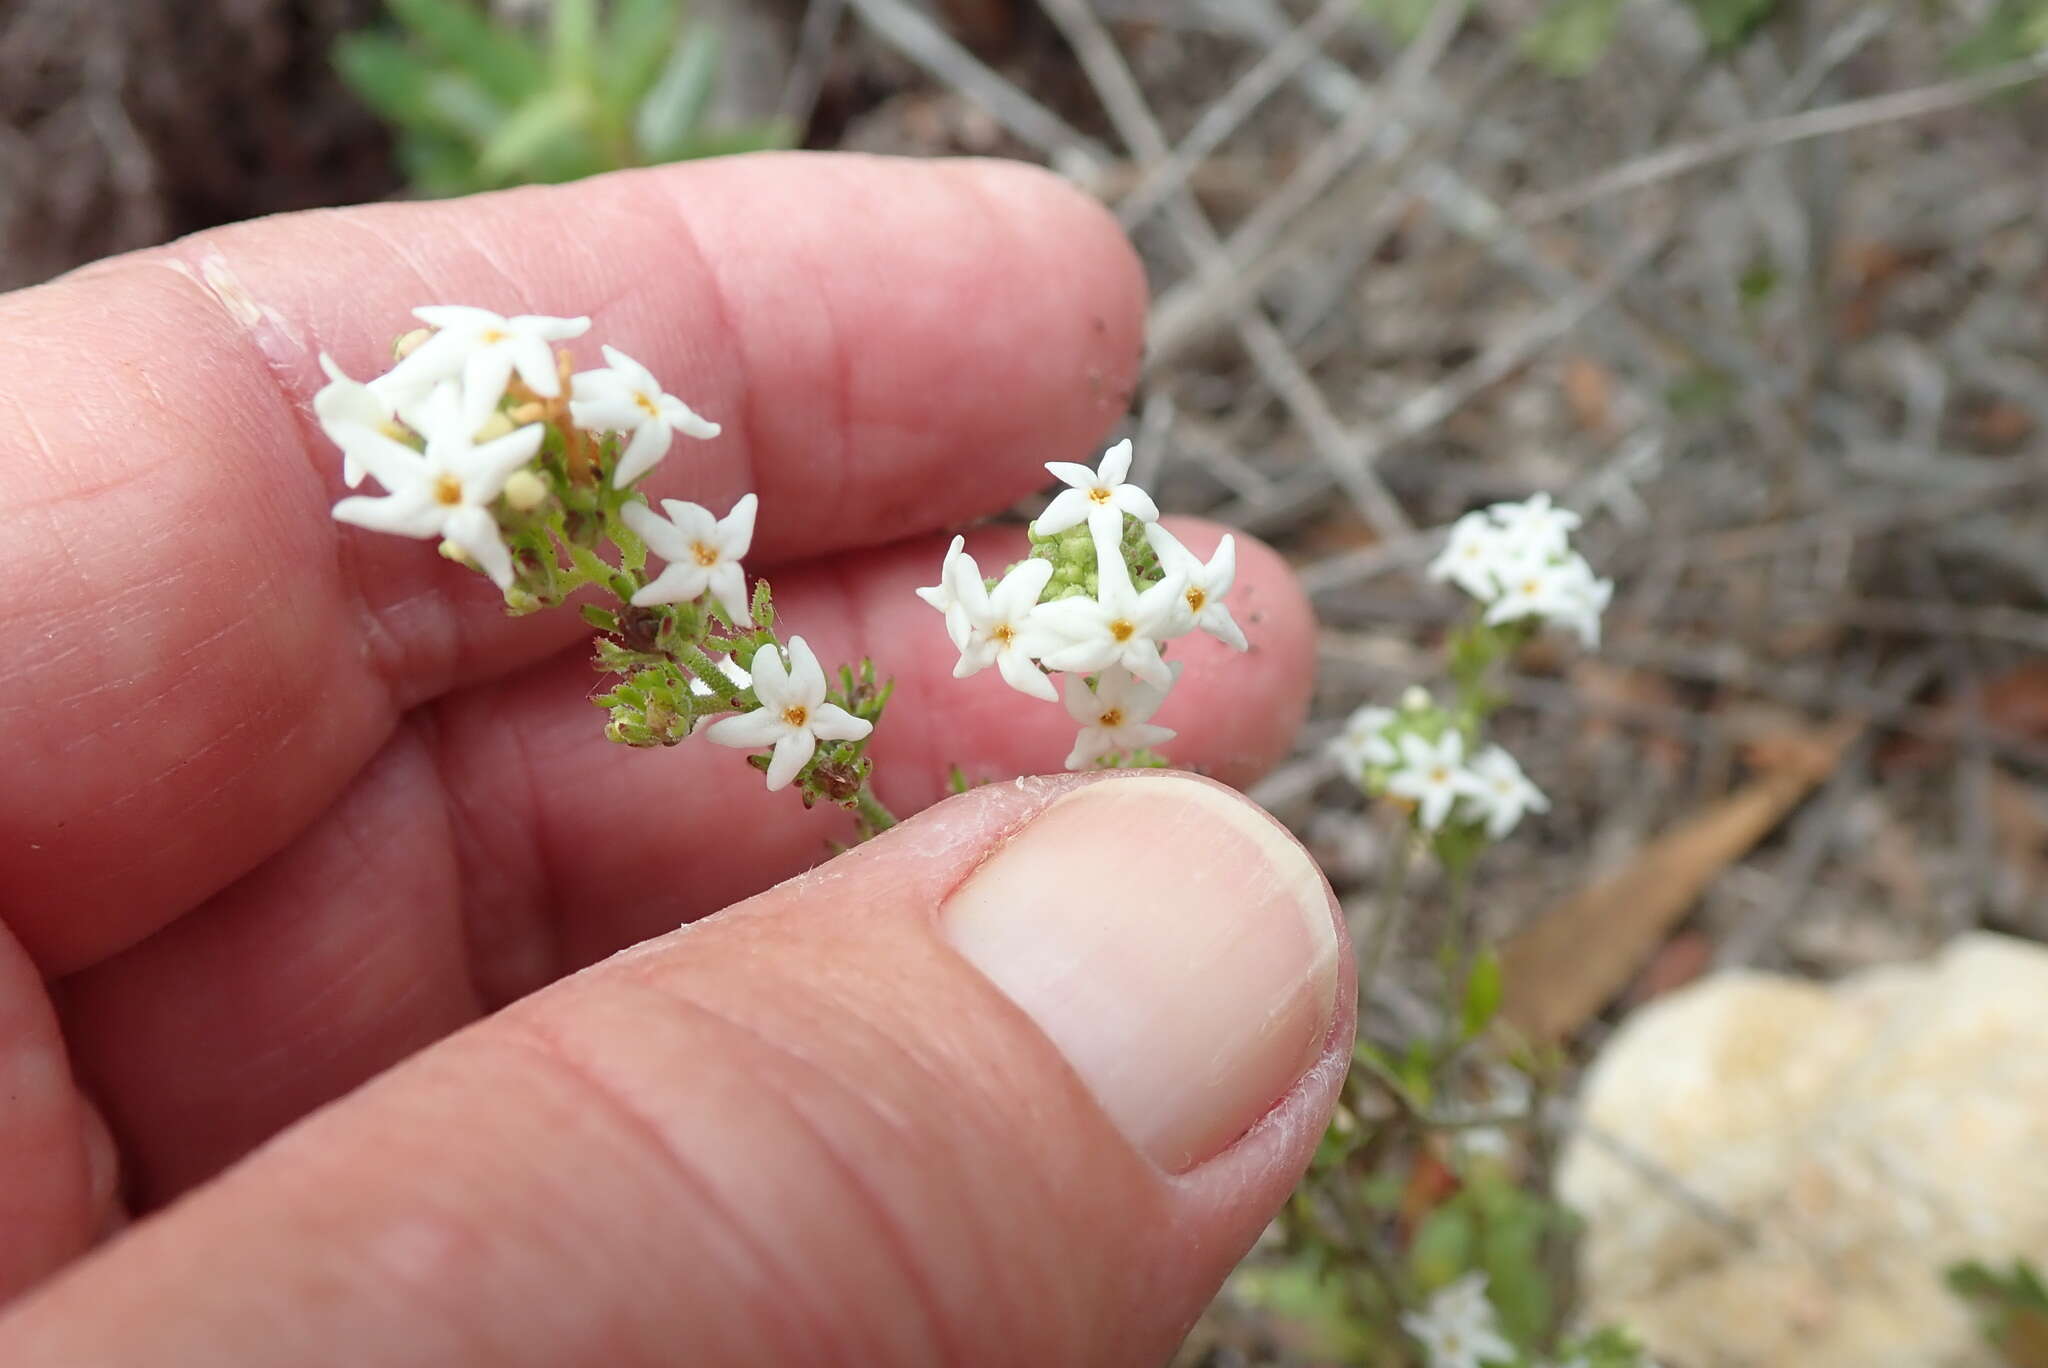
918;442;1245;770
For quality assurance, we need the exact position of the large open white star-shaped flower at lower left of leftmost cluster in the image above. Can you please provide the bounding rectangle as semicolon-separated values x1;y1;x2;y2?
334;385;543;590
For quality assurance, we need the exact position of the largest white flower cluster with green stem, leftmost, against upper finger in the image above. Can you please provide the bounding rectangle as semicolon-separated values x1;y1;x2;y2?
313;305;889;810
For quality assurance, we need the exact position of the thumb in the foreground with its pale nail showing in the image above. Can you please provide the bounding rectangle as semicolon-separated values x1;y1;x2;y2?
0;774;1352;1368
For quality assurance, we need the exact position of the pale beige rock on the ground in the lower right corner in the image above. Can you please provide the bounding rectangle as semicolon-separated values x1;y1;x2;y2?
1559;936;2048;1368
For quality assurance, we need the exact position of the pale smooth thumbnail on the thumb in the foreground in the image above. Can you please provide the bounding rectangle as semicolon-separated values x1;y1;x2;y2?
940;774;1337;1173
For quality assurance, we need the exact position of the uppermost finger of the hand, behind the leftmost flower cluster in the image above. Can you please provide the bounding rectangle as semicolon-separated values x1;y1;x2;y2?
0;156;1143;973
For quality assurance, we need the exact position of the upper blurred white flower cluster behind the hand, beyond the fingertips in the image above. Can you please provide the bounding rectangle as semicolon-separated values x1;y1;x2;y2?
1427;494;1614;647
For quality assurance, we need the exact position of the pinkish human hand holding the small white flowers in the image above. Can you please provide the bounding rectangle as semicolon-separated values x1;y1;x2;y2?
0;156;1352;1366
